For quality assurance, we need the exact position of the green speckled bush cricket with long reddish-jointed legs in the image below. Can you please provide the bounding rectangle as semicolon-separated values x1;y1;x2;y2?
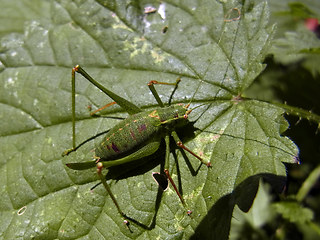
63;65;210;222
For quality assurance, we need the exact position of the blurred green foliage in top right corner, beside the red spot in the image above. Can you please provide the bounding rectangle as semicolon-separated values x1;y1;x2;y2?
270;0;320;77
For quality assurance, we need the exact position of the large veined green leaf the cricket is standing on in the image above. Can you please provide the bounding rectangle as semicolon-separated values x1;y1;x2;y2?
0;0;298;239
